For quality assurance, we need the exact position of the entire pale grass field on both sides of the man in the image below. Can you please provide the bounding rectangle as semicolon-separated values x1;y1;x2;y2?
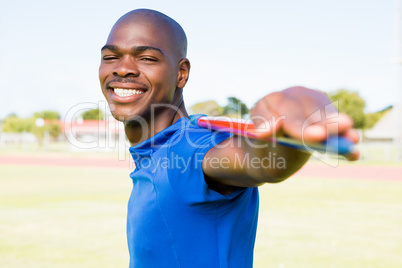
0;162;402;268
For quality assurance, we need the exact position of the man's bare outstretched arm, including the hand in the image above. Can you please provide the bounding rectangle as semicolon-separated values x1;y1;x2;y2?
203;87;359;192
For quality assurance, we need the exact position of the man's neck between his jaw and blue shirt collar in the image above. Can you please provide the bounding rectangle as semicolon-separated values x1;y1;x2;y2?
124;94;188;146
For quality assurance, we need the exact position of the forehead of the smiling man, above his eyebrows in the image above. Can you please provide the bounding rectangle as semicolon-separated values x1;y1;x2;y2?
107;21;177;54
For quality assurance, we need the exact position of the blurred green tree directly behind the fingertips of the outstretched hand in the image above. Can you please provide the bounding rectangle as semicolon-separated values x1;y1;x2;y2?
329;89;366;129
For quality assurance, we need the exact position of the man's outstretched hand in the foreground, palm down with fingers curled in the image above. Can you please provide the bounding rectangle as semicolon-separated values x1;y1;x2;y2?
250;87;359;160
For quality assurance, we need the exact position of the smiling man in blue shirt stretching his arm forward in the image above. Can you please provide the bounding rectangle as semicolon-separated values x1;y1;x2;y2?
99;9;358;267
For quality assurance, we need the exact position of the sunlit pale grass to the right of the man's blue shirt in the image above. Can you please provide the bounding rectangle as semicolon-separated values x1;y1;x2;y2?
255;174;402;267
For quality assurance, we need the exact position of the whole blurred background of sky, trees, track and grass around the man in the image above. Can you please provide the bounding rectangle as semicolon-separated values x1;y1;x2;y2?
0;0;402;267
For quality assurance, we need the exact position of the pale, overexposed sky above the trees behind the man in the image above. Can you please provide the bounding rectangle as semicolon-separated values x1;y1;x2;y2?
0;0;402;119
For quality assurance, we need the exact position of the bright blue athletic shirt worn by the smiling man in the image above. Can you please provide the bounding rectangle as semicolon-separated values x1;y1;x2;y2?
127;118;258;268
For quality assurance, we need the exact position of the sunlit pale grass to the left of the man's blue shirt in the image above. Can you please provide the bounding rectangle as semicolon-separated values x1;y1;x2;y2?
0;166;131;267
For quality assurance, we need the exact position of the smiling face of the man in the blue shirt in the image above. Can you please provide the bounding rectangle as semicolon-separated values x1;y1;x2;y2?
99;21;180;121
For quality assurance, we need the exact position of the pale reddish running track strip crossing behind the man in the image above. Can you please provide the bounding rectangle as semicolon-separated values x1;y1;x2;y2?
0;155;402;182
